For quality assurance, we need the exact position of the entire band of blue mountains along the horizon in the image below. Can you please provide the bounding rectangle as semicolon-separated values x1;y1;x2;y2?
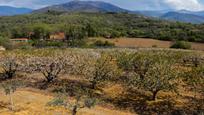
0;0;204;24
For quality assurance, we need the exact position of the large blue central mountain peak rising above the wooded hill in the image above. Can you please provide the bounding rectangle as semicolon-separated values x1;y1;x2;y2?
34;1;128;13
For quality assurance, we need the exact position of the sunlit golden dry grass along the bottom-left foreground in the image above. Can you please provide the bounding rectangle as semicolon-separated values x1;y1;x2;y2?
0;89;132;115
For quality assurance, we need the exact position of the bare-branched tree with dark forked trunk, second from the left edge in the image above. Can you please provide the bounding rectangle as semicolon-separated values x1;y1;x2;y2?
21;54;69;82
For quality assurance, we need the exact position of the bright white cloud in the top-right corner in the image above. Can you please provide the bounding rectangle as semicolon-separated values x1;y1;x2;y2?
164;0;204;11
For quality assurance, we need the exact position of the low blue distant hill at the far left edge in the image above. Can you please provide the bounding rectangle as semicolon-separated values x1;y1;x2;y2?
0;6;32;16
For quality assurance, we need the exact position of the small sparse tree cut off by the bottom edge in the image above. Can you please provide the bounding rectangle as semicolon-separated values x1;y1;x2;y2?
47;85;96;115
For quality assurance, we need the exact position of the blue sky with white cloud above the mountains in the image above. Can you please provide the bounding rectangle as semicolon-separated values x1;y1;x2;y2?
0;0;204;11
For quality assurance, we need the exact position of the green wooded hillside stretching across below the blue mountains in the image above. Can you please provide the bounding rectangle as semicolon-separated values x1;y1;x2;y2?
0;12;204;42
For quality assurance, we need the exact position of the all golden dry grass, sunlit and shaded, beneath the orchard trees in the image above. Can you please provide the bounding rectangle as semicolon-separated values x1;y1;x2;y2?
0;74;201;115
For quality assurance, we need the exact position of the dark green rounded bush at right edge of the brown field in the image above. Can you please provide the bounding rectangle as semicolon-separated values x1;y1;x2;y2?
170;41;191;49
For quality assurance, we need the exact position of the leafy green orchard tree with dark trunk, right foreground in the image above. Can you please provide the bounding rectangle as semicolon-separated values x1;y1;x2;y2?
129;58;177;100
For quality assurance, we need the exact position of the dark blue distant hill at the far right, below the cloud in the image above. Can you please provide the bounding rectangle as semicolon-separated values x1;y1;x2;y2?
160;12;204;24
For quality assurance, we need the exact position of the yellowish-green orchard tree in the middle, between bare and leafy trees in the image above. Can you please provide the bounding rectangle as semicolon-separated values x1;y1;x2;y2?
84;53;121;89
